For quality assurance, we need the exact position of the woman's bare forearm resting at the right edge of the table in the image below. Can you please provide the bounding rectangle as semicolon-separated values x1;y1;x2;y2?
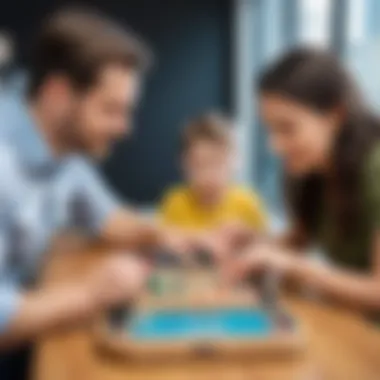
291;258;380;310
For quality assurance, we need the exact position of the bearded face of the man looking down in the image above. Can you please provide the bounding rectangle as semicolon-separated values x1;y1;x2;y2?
64;66;139;158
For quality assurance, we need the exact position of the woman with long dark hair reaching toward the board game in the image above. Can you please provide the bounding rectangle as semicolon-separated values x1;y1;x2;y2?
231;49;380;310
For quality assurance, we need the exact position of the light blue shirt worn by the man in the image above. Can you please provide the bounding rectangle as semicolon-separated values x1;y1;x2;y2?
0;99;119;334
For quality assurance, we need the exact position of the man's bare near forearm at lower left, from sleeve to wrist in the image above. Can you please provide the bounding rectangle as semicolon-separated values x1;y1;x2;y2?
0;284;97;350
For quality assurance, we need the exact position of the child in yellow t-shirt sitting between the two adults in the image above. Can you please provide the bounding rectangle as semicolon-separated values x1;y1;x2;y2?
160;114;266;256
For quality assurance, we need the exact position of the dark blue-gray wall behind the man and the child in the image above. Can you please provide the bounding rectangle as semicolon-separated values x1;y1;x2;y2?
0;0;231;203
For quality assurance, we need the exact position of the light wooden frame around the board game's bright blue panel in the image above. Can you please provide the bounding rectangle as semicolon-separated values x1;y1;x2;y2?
95;270;305;360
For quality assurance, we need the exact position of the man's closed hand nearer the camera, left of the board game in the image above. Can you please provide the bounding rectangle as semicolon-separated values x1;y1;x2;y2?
87;253;150;310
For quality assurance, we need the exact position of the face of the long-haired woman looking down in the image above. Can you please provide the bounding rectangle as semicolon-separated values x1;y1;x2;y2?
260;94;338;176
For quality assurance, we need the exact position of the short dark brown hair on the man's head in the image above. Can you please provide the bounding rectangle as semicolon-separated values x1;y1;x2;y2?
28;9;150;97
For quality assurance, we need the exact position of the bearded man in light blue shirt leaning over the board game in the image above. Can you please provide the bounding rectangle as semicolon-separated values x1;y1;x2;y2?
0;7;190;378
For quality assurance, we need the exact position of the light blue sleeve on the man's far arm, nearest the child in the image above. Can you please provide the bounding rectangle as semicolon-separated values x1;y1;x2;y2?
71;161;122;234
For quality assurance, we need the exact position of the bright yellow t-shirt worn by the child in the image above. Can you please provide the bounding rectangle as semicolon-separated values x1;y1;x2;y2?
160;186;267;230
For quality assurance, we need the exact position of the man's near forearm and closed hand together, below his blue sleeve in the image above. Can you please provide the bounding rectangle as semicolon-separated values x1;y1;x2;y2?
0;254;149;350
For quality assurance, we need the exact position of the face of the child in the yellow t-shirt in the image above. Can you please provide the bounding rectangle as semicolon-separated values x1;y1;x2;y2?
183;141;234;195
